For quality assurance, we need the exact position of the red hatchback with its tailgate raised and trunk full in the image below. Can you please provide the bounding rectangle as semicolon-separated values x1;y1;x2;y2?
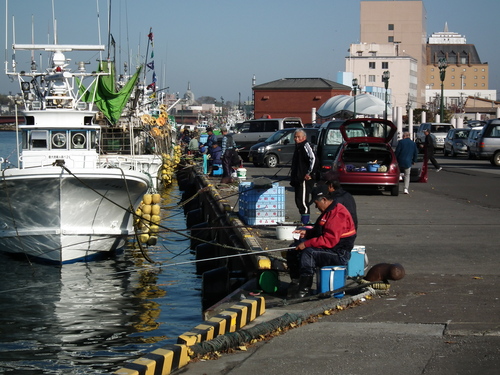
333;118;399;196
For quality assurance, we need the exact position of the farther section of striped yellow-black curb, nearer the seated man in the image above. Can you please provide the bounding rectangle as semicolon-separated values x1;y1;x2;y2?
177;297;266;346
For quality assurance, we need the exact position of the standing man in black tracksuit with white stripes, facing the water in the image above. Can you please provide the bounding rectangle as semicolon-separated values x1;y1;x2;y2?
290;129;316;224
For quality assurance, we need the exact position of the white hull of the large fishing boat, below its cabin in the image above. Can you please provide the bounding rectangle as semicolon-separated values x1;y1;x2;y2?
0;167;149;264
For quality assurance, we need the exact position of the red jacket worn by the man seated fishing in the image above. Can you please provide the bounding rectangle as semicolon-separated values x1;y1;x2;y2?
304;203;356;249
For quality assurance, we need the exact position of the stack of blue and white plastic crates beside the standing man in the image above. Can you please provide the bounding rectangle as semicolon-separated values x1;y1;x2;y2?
238;182;285;225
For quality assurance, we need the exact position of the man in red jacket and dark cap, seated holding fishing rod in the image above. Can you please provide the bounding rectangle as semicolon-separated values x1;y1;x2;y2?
287;185;356;298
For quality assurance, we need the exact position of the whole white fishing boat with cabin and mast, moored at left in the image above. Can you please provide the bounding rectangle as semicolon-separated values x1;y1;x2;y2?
0;44;151;264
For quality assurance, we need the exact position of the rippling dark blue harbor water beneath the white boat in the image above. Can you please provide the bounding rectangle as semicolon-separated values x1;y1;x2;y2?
0;132;202;375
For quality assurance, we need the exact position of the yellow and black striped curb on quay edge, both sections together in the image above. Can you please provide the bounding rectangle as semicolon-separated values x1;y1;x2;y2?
113;297;266;375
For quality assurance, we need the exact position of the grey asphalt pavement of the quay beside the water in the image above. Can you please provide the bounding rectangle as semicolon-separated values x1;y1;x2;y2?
177;157;500;375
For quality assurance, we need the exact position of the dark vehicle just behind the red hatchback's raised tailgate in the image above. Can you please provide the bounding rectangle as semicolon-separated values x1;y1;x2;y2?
317;120;366;177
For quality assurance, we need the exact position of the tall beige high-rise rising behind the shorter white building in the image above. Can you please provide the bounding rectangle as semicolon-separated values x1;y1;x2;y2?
360;1;427;107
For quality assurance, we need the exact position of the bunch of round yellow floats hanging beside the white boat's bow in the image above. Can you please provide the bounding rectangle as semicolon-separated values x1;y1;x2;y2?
135;194;161;246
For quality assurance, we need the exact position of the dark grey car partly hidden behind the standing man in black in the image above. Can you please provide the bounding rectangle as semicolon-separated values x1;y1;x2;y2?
248;128;318;168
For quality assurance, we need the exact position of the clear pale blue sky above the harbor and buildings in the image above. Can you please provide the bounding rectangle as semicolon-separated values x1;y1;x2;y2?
0;0;500;101
